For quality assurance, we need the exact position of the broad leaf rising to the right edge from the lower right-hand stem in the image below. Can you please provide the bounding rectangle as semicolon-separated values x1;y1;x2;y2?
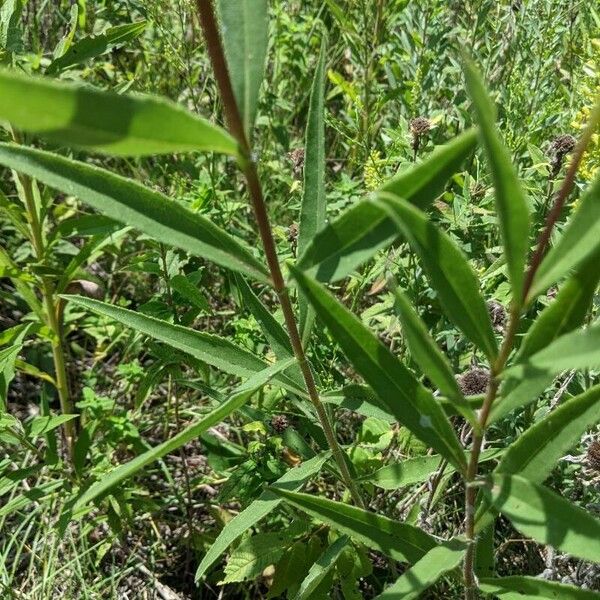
496;386;600;483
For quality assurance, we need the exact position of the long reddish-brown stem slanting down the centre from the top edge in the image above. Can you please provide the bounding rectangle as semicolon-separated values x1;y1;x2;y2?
196;0;365;508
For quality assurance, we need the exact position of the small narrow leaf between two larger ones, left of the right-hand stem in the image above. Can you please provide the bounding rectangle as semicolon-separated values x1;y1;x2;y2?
392;282;477;427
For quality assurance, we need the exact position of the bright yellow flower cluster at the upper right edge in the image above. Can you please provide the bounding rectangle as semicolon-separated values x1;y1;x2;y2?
572;39;600;181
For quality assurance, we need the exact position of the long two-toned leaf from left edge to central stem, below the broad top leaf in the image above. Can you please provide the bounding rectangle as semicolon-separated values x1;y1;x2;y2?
0;146;269;283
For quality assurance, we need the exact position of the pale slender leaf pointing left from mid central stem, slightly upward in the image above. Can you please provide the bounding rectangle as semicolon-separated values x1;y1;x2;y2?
64;295;303;394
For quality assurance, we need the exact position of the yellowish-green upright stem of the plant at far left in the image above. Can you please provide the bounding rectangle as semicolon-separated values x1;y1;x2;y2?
11;130;76;459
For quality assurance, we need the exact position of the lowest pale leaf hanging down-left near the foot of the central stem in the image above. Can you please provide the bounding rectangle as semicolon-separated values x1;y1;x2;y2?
196;452;329;581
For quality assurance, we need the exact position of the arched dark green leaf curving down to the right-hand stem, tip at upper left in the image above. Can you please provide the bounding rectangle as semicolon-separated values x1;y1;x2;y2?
375;193;497;361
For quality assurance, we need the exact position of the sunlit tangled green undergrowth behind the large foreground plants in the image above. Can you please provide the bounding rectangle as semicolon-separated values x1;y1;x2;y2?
0;0;600;600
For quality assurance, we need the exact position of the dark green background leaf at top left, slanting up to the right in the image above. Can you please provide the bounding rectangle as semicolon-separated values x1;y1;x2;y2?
46;17;146;75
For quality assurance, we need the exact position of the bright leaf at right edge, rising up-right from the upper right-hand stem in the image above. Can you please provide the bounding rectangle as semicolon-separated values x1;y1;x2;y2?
529;171;600;299
